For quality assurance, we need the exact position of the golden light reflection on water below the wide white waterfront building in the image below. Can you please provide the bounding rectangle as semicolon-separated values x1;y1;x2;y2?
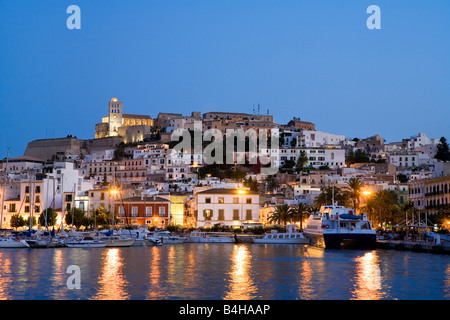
224;245;258;300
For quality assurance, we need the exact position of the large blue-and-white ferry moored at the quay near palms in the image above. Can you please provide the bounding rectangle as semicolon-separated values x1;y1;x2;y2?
304;205;376;248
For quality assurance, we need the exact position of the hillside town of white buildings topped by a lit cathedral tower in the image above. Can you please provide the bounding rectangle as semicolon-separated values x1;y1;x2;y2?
0;98;450;230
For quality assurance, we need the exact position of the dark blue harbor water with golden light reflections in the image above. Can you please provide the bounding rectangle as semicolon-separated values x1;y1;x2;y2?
0;243;450;300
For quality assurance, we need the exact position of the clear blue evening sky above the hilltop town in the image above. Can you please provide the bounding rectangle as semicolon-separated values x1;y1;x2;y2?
0;0;450;158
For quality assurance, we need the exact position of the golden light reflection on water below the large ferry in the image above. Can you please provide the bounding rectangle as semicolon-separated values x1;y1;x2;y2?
352;252;383;300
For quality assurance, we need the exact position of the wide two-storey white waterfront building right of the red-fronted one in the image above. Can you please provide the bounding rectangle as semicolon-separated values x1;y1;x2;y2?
195;189;259;227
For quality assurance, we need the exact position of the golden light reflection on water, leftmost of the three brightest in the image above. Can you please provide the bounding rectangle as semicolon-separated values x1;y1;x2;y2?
94;248;129;300
